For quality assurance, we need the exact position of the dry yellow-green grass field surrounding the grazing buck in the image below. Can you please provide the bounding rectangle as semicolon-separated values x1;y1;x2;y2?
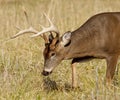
0;0;120;100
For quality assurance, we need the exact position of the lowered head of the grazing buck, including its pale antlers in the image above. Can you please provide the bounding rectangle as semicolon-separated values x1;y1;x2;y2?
11;14;71;76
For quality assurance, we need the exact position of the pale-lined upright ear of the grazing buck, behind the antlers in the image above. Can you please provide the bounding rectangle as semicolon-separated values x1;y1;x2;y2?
61;31;71;46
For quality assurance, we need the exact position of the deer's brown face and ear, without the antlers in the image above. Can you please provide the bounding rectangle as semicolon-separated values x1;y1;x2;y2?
42;32;71;75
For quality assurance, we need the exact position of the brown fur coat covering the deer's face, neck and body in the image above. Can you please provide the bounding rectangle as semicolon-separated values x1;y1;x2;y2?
44;12;120;87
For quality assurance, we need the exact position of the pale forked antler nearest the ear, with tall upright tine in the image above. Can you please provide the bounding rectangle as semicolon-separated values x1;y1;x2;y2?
31;13;59;37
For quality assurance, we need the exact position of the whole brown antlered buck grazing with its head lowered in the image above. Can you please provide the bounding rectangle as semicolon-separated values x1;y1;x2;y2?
12;12;120;87
